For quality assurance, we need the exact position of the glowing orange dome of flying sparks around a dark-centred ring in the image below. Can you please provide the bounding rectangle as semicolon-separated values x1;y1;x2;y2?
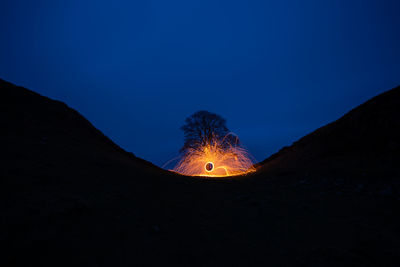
173;134;255;177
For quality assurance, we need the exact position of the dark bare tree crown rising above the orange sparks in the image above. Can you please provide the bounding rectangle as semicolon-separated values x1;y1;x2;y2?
180;110;238;153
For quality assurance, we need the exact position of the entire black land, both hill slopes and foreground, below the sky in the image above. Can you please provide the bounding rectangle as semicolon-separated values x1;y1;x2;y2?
0;80;400;267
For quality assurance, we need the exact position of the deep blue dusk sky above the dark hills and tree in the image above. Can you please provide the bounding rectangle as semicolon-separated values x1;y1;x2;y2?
0;0;400;168
